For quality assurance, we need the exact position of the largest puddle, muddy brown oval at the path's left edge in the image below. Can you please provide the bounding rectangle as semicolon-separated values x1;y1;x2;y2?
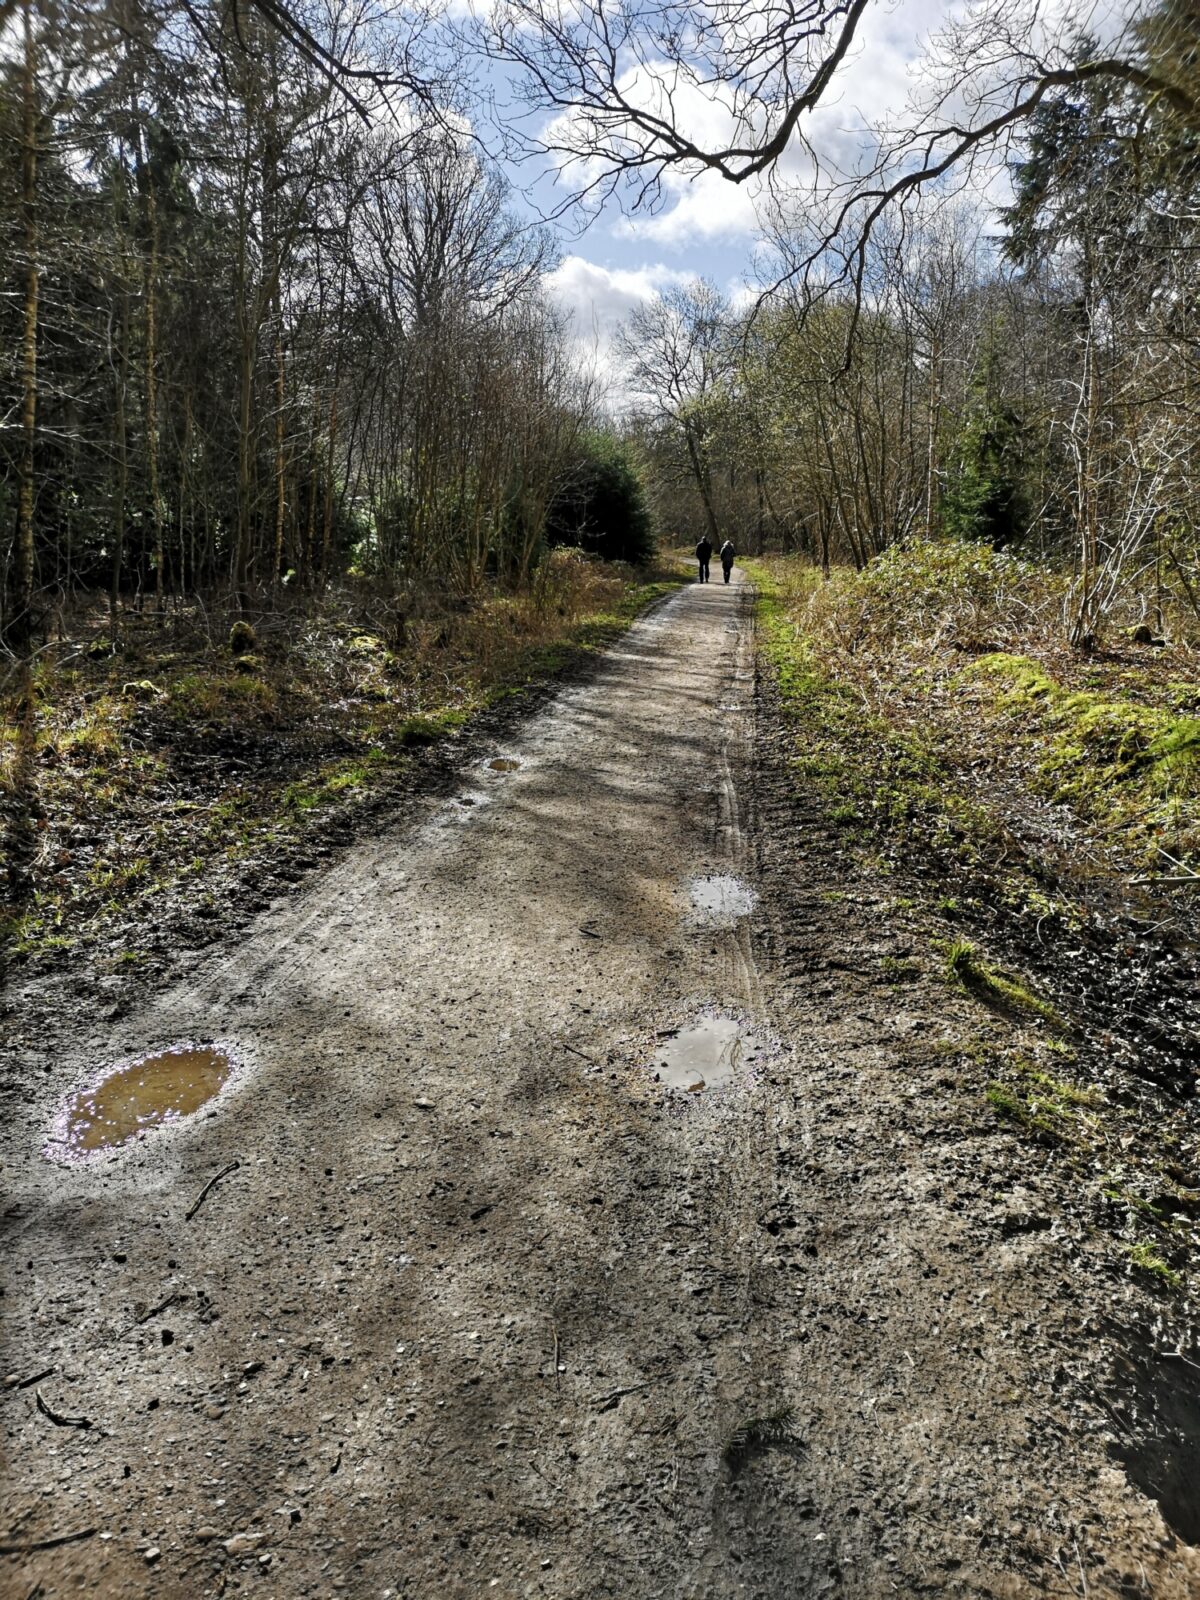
51;1045;234;1155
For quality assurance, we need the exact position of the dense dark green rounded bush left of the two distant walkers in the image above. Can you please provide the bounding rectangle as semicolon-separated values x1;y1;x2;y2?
546;434;654;563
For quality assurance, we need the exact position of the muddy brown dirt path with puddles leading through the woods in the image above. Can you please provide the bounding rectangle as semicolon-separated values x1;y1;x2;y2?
0;584;1200;1600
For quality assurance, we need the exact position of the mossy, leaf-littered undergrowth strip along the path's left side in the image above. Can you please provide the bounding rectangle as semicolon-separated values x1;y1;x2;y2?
0;550;682;960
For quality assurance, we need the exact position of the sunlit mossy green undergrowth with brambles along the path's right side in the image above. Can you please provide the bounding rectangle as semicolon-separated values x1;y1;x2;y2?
750;544;1200;1288
